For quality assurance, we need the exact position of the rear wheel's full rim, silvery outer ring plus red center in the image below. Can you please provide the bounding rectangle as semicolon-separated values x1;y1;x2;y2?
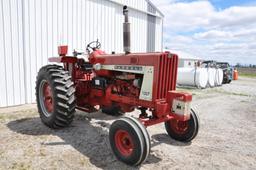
39;80;54;117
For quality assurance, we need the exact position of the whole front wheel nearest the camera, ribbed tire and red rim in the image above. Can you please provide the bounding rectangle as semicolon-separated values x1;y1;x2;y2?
109;117;150;166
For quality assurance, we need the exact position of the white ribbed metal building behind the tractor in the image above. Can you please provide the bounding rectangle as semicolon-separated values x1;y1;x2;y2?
0;0;163;107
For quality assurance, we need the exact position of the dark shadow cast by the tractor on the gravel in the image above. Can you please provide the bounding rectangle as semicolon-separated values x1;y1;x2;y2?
7;113;161;170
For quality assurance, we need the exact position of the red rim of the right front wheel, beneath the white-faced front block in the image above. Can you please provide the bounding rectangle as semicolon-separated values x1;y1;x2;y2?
170;119;189;134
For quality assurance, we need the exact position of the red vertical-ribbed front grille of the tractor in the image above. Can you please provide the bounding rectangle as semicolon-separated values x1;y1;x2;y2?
156;53;178;99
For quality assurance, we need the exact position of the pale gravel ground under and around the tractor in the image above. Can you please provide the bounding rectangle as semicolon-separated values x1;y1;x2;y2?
0;78;256;170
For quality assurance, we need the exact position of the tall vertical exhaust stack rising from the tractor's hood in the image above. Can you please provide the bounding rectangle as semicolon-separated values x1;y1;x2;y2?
123;6;131;54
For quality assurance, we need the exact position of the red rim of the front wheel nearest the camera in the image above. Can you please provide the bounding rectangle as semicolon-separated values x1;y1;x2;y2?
115;130;134;156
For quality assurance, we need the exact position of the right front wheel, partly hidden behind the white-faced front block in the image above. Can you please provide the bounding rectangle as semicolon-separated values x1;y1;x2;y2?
165;109;199;142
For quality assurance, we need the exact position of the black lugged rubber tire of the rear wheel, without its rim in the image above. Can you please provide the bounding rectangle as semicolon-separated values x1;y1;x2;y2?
36;65;76;128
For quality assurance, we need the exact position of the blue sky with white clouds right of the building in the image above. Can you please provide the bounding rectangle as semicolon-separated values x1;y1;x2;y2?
152;0;256;64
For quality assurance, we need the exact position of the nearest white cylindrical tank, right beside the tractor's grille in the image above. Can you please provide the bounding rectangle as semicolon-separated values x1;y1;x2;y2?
177;67;208;88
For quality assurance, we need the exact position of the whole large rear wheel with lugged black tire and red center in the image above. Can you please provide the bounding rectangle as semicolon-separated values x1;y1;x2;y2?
36;65;76;128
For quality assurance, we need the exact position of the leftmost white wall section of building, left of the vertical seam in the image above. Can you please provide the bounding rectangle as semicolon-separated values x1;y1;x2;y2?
0;0;25;107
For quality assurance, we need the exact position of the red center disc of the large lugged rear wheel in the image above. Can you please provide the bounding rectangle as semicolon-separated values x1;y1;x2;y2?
42;82;53;113
